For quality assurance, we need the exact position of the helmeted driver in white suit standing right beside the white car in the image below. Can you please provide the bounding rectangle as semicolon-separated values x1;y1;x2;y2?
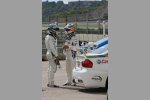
63;24;79;86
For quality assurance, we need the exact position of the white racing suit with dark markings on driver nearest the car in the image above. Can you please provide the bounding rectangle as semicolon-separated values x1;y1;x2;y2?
63;33;79;84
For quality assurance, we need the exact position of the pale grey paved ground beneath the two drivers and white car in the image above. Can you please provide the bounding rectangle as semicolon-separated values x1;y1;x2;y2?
42;61;107;100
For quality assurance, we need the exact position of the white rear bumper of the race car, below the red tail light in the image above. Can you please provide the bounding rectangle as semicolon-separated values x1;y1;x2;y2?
73;68;107;88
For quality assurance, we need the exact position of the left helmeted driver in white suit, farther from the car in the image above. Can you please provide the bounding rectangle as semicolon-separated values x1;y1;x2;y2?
45;24;59;87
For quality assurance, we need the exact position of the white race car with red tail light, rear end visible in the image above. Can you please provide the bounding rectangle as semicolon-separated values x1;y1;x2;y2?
73;38;108;89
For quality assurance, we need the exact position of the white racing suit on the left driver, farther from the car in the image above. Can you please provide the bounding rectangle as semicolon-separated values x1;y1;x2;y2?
45;35;58;85
